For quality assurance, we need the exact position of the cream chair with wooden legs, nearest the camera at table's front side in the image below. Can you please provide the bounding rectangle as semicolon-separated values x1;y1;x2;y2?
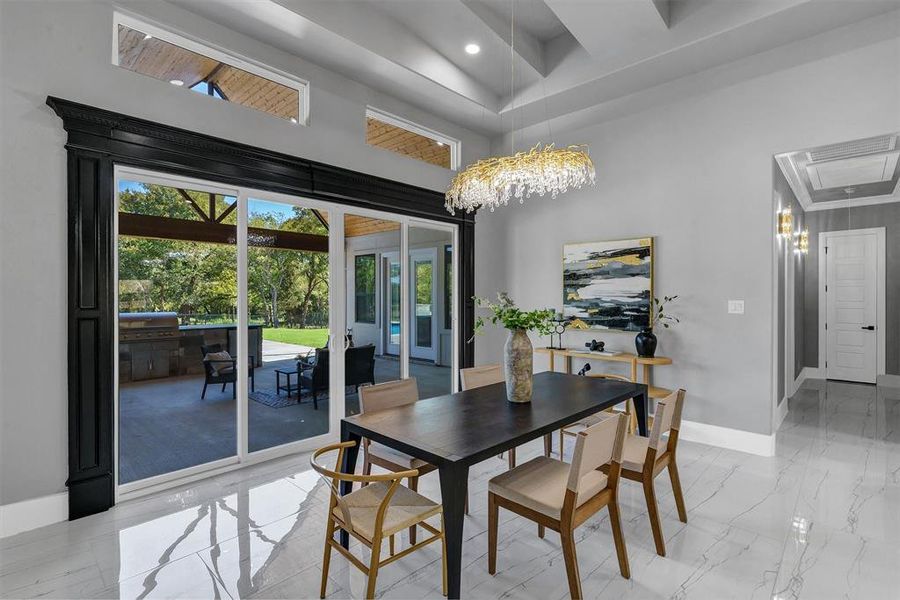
488;414;631;598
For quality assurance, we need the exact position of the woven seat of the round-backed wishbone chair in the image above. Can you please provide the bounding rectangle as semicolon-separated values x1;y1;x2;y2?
332;481;441;541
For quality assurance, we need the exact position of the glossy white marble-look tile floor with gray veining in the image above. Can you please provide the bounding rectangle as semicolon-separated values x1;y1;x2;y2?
0;382;900;600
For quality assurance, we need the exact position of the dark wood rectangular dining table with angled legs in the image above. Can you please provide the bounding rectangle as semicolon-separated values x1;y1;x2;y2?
341;371;648;598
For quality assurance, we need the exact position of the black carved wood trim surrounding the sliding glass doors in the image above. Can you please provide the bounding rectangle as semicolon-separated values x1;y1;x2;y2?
47;96;475;519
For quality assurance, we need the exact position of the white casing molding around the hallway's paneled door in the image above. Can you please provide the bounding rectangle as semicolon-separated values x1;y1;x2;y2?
818;227;887;379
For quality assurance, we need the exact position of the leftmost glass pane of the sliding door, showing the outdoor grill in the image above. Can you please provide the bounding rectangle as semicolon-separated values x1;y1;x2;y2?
117;181;237;484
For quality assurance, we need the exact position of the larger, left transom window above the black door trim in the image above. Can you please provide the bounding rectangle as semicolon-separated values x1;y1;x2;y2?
113;13;309;125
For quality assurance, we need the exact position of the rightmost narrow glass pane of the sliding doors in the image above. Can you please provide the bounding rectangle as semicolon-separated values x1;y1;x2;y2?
409;225;453;398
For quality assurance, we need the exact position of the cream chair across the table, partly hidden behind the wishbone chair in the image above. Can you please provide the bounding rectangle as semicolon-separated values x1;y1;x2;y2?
359;377;437;544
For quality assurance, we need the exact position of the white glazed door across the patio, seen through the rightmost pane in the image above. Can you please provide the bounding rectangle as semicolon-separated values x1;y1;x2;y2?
409;248;437;360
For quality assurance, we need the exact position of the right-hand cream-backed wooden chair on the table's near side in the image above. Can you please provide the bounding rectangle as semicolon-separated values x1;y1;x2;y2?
604;390;687;556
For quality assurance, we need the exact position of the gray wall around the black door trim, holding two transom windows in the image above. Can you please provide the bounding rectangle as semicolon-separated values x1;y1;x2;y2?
0;0;489;504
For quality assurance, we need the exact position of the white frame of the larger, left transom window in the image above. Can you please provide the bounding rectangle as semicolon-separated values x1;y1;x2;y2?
112;10;309;126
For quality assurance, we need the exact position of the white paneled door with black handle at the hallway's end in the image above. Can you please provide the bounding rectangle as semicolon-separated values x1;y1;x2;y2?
825;233;878;383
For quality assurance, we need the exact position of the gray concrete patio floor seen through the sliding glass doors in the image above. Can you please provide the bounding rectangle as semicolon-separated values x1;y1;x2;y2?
119;358;451;483
